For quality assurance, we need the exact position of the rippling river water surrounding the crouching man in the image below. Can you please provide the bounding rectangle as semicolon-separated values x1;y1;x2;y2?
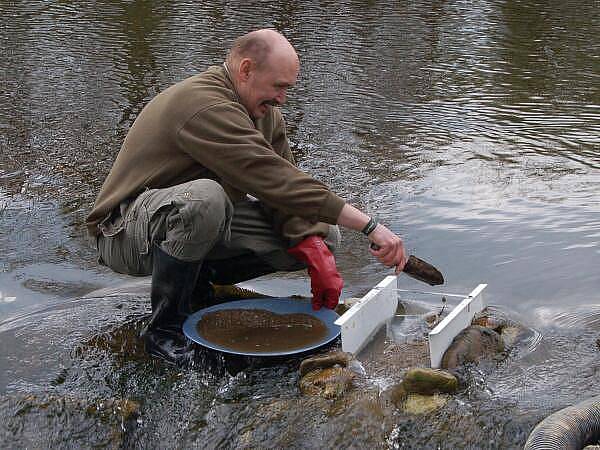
0;0;600;448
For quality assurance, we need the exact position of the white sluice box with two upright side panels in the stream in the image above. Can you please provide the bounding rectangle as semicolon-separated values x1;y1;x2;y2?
335;276;487;368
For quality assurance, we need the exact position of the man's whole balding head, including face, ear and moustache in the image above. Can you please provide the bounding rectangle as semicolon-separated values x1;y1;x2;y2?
226;29;300;119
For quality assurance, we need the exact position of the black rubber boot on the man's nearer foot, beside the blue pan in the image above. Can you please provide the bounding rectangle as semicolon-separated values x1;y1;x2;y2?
141;245;202;365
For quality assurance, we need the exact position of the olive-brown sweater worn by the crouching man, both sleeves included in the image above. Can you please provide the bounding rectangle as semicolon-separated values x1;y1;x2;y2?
86;66;344;240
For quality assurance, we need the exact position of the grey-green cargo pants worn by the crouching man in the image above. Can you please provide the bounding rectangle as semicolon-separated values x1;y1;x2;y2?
97;179;340;276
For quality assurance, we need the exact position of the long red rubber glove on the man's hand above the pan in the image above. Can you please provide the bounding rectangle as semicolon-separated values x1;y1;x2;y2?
288;236;344;310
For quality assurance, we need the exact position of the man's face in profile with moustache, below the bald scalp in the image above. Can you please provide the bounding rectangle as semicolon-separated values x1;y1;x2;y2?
239;58;299;119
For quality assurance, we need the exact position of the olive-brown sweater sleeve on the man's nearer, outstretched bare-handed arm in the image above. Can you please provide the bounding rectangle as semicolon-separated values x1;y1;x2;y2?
176;102;345;224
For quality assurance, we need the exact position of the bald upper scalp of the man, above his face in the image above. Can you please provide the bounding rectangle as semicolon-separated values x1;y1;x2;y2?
226;28;298;73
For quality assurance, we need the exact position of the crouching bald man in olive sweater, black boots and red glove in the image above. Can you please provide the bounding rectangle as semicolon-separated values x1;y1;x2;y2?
87;29;406;362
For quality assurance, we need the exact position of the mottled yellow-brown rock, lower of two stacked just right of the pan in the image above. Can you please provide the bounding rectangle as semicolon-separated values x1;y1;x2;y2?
299;367;356;399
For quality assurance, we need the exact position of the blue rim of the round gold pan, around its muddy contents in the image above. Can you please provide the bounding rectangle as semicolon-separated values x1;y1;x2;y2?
183;298;340;356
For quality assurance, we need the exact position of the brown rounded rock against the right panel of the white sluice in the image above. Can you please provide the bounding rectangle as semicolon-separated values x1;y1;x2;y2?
442;325;504;369
